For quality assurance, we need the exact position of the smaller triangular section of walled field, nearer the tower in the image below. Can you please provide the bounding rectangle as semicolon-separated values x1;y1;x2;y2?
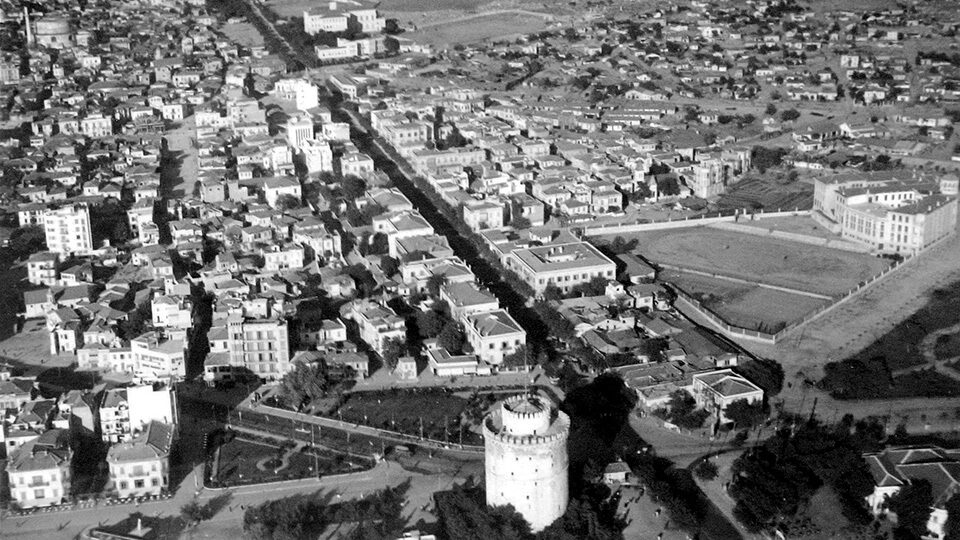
660;271;828;330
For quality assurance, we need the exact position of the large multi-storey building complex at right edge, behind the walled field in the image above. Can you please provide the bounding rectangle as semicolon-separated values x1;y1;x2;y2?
813;174;957;254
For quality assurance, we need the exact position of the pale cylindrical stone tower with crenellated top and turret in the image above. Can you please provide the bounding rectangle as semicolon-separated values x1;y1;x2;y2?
483;395;570;532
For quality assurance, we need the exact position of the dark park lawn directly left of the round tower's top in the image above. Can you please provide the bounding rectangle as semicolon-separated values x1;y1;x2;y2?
330;388;483;444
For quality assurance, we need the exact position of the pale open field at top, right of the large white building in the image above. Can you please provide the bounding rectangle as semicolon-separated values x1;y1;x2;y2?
404;12;548;47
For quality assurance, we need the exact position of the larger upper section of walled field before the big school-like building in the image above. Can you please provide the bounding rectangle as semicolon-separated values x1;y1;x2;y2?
628;227;889;296
